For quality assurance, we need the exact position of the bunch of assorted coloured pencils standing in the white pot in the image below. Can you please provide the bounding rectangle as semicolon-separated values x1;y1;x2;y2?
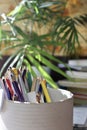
0;67;51;103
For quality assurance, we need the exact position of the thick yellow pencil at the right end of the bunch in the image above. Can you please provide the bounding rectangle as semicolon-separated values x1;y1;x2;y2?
41;80;51;103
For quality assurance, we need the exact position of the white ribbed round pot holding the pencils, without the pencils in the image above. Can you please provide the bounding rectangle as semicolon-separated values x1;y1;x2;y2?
0;88;73;130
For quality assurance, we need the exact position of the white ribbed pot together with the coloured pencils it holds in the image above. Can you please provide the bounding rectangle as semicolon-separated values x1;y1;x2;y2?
0;68;73;130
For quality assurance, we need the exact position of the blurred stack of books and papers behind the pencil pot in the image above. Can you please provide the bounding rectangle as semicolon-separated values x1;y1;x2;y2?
58;60;87;105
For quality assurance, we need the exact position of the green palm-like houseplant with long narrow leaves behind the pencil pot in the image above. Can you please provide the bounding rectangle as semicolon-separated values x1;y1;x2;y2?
0;0;87;88
